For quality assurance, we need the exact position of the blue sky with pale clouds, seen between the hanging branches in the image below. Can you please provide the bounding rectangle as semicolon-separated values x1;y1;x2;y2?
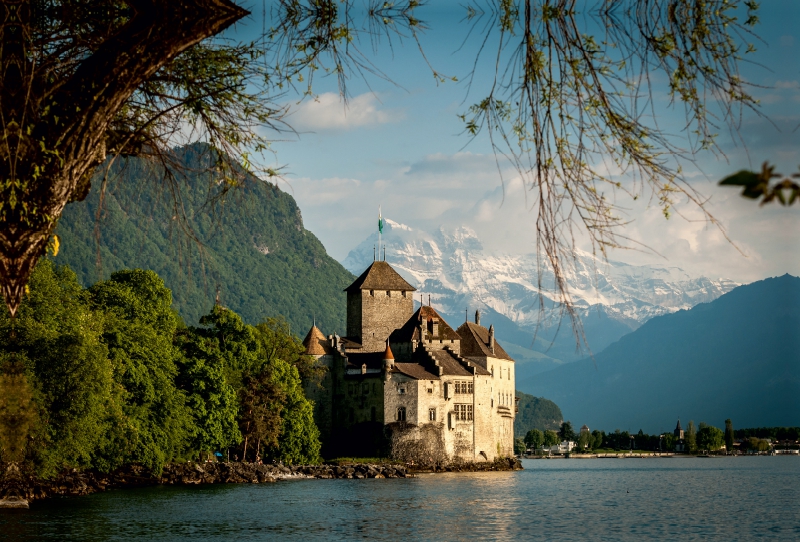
228;0;800;282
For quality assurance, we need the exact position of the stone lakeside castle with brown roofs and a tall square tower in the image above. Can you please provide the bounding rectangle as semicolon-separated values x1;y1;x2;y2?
303;261;516;461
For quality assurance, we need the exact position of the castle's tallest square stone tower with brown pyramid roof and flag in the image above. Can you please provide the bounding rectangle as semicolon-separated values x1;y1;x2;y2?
345;261;416;352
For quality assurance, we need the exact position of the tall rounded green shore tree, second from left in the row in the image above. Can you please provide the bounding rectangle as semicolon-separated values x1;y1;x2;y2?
89;269;192;473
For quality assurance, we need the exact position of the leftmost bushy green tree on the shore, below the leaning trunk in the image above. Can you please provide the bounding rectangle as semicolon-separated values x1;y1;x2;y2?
0;258;116;476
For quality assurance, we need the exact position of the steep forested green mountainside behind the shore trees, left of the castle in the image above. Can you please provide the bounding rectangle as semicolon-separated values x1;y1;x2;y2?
56;144;354;334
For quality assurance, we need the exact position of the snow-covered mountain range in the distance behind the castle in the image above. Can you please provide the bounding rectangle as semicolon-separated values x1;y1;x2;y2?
342;219;738;364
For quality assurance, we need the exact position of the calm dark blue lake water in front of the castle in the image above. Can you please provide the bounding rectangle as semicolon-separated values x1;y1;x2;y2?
0;457;800;541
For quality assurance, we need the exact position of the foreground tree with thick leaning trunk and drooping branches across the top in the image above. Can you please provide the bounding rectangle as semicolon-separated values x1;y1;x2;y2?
0;0;758;327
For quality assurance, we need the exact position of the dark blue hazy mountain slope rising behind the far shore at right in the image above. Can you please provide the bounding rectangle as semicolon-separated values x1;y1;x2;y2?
517;275;800;432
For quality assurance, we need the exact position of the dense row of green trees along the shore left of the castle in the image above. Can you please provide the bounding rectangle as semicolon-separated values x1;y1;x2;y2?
0;258;320;476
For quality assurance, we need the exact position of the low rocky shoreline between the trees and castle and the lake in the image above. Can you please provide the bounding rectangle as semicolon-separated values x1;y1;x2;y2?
0;458;522;508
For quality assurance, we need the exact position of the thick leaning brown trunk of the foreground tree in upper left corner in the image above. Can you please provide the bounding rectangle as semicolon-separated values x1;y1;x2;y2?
0;0;253;315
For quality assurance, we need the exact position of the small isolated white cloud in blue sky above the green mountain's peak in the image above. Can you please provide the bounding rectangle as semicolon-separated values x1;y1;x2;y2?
286;92;405;132
